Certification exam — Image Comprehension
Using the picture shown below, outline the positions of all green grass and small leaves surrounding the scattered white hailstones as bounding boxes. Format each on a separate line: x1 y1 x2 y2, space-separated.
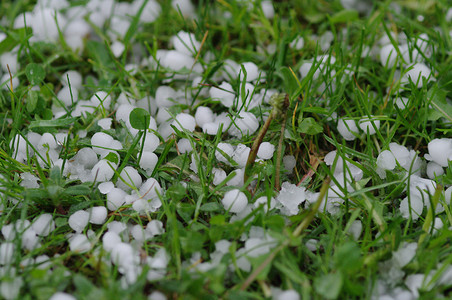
0 0 452 299
